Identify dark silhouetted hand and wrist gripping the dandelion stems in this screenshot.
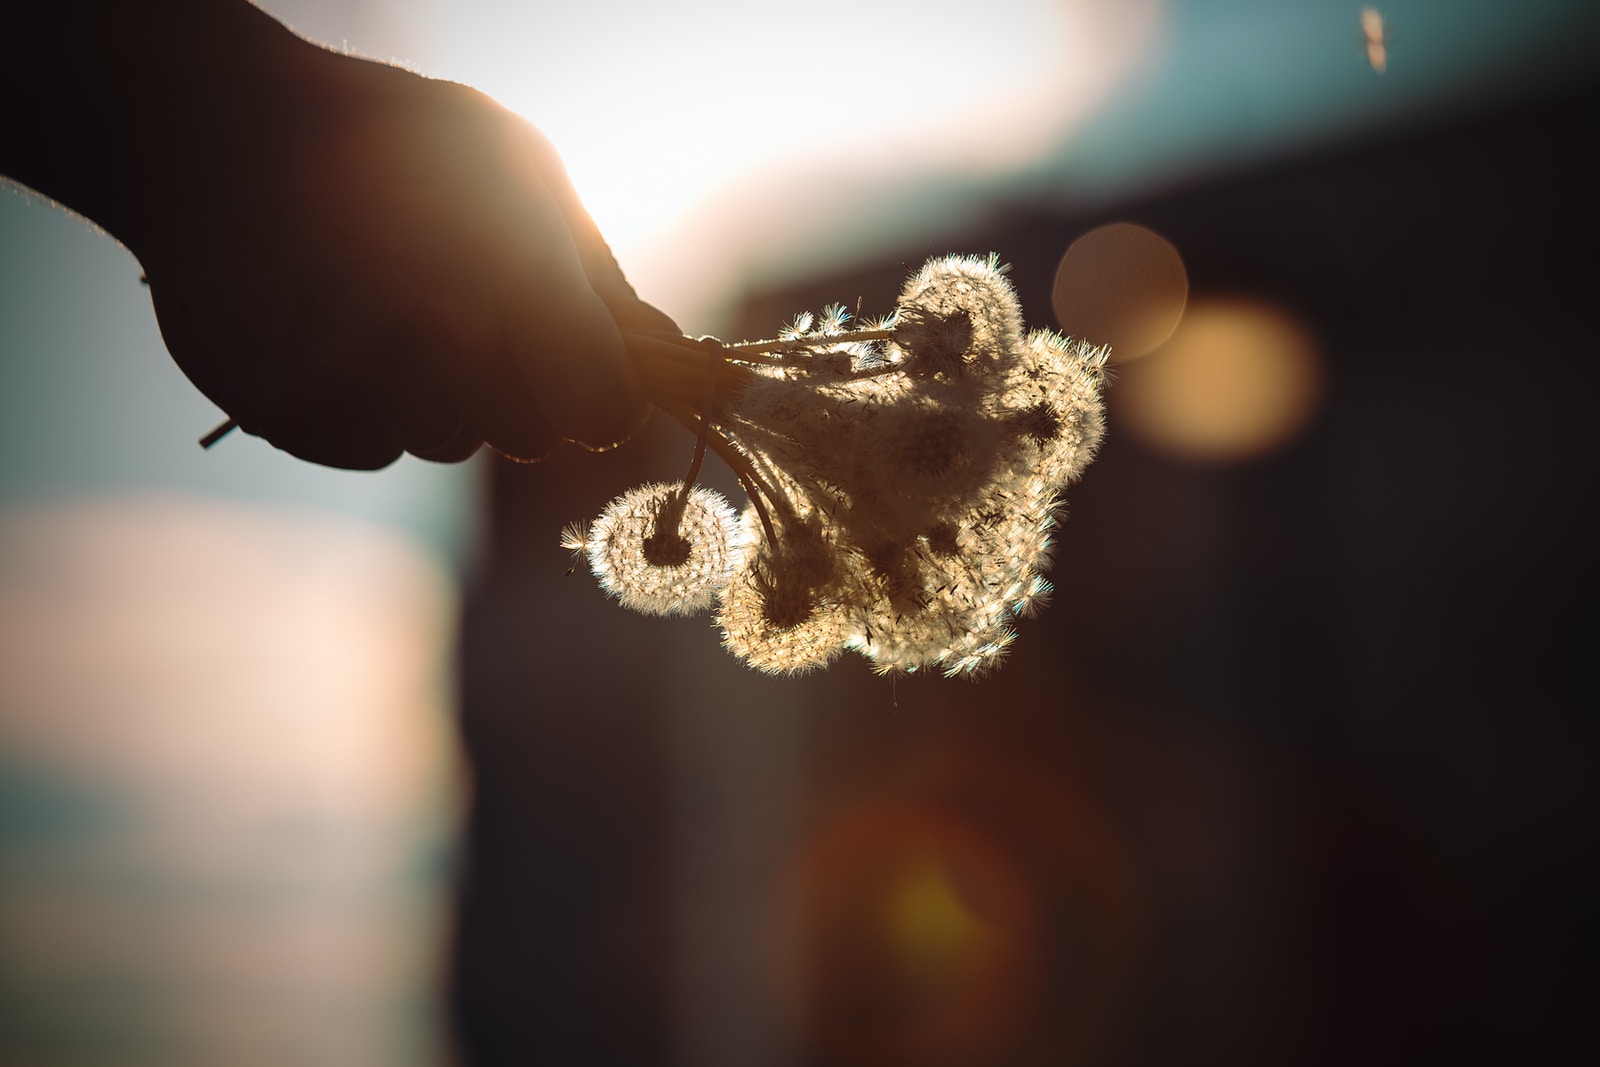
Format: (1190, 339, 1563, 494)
(0, 0, 675, 469)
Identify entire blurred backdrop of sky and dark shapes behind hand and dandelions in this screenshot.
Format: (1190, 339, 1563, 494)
(0, 0, 1600, 1067)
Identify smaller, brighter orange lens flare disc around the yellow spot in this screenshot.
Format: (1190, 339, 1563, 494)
(773, 803, 1040, 1064)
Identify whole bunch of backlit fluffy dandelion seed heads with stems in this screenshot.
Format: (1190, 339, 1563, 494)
(562, 256, 1109, 675)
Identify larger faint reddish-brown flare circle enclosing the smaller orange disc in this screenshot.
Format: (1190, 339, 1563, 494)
(765, 748, 1146, 1067)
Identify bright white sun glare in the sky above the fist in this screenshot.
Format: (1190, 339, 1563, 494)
(427, 0, 1157, 321)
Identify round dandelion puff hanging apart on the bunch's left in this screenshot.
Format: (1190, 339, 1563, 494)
(584, 485, 742, 614)
